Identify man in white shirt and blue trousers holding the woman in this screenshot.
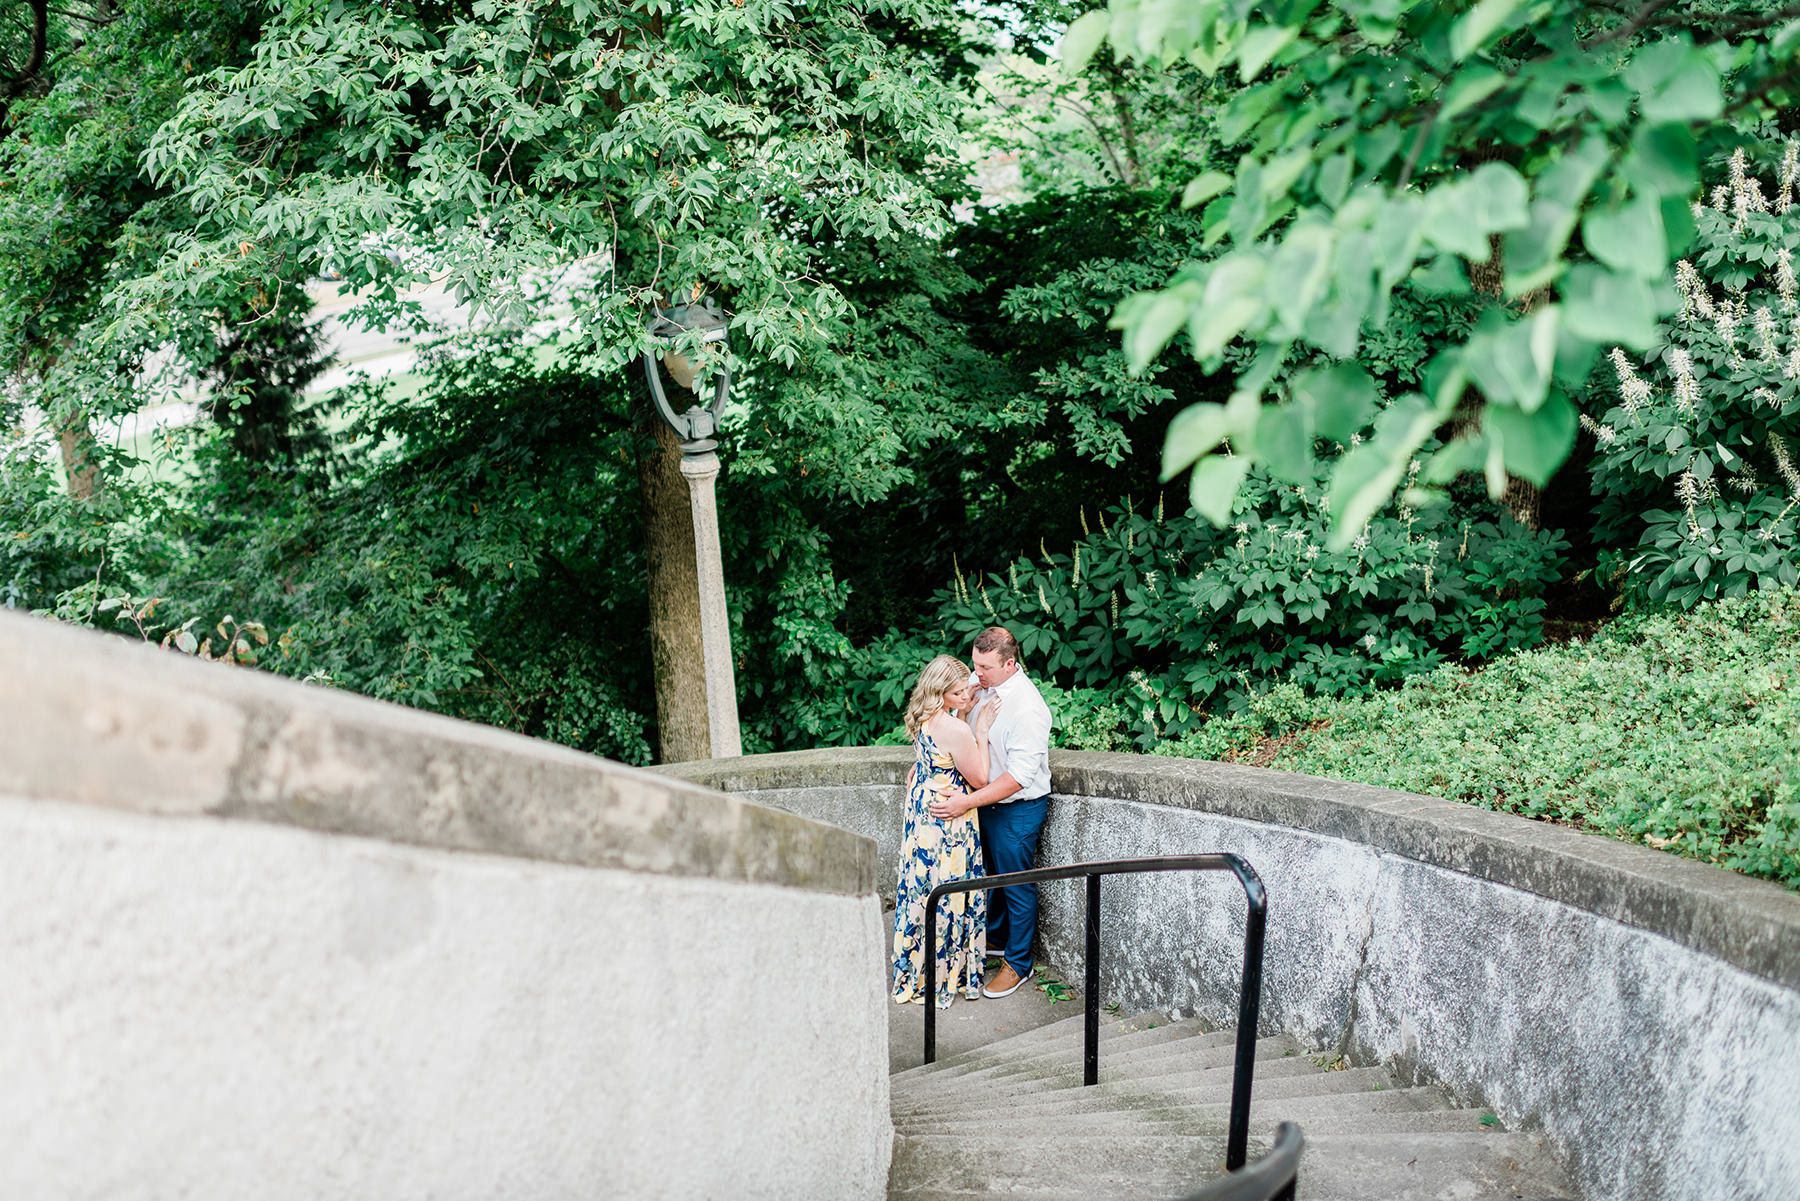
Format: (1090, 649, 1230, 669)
(931, 625, 1051, 998)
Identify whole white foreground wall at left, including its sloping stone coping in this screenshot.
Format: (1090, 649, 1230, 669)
(0, 612, 893, 1201)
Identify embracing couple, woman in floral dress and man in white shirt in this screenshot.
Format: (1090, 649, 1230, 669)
(893, 625, 1051, 1008)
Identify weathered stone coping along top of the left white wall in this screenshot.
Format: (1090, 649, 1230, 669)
(0, 610, 877, 895)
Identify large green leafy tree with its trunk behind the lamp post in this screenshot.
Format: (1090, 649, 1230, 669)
(95, 0, 954, 758)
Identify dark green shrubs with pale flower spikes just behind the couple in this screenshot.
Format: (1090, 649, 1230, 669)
(892, 466, 1566, 747)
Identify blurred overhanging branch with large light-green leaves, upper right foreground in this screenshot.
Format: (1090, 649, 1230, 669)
(1066, 0, 1800, 546)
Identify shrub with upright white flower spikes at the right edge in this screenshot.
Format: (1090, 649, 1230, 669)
(1584, 144, 1800, 607)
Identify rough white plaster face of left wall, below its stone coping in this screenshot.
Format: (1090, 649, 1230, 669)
(0, 798, 891, 1201)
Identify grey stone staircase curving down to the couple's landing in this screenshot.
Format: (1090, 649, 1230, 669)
(887, 1014, 1573, 1201)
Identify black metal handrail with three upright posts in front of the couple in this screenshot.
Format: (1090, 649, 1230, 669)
(925, 853, 1269, 1172)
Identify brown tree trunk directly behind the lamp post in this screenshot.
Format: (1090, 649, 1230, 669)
(634, 415, 713, 763)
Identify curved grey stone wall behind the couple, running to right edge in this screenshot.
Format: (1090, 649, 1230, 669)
(666, 749, 1800, 1201)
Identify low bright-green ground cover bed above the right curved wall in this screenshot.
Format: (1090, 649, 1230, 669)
(1157, 589, 1800, 889)
